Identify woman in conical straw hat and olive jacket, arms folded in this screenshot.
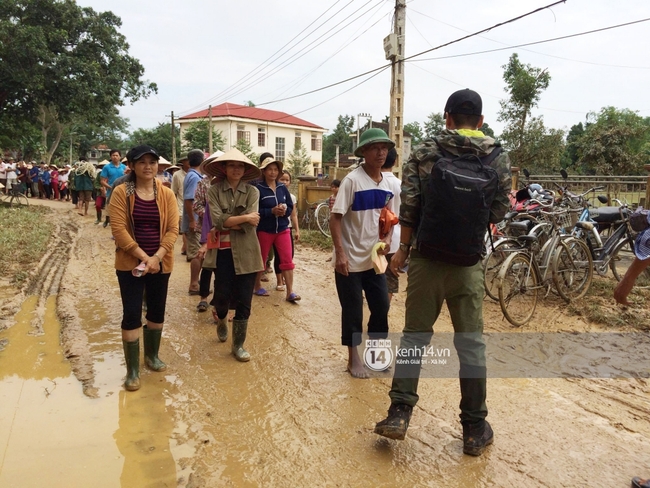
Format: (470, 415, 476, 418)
(203, 148, 264, 361)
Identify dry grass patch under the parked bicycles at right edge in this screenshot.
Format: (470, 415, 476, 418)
(567, 276, 650, 331)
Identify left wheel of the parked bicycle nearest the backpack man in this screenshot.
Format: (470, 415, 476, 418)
(499, 252, 540, 327)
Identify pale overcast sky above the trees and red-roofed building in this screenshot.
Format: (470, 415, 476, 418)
(77, 0, 650, 135)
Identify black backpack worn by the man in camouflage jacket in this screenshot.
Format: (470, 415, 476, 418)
(417, 141, 502, 266)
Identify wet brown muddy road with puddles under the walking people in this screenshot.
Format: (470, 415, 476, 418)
(0, 199, 650, 488)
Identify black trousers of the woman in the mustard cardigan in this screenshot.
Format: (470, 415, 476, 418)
(116, 271, 171, 330)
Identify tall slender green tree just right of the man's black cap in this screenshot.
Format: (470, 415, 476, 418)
(498, 53, 564, 173)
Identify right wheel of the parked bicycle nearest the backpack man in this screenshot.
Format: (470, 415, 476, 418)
(551, 237, 594, 302)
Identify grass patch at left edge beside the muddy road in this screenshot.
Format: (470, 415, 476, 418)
(0, 205, 54, 285)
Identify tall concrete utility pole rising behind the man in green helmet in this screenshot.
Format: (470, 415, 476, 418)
(384, 0, 406, 177)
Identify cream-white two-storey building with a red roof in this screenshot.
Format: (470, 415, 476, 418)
(178, 103, 327, 176)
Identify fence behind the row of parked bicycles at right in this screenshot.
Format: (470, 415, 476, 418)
(512, 164, 650, 207)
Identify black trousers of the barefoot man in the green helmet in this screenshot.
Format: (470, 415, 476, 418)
(334, 269, 390, 347)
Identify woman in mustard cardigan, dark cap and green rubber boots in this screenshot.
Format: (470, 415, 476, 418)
(109, 145, 178, 391)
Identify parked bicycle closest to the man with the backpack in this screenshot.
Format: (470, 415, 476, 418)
(498, 205, 593, 326)
